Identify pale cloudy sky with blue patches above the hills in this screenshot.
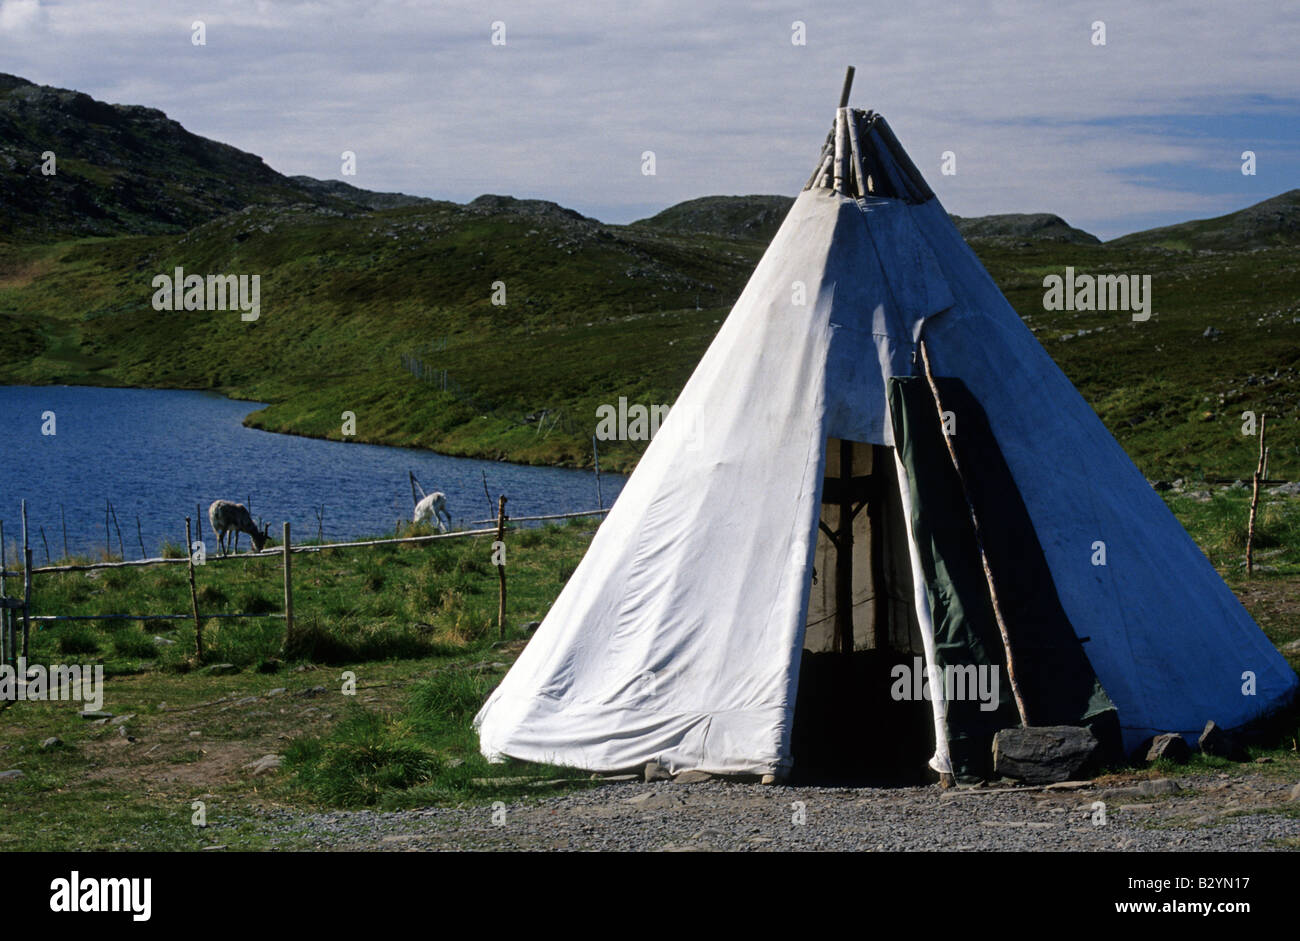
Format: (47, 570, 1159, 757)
(0, 0, 1300, 239)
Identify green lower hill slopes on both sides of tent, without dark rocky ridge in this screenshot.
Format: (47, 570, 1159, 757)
(0, 204, 1300, 478)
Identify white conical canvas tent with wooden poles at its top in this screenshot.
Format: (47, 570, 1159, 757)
(475, 102, 1296, 777)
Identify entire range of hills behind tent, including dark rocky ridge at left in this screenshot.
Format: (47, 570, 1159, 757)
(0, 75, 1300, 477)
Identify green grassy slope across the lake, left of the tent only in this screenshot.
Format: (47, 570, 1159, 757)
(0, 198, 762, 468)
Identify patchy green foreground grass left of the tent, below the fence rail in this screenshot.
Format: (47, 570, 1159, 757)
(0, 521, 590, 850)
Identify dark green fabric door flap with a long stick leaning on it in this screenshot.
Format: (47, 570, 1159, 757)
(889, 377, 1119, 776)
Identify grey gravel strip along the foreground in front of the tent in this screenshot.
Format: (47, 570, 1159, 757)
(245, 773, 1300, 851)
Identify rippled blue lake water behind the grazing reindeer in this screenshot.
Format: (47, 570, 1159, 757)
(0, 386, 624, 565)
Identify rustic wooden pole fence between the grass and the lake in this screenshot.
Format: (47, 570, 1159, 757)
(0, 496, 608, 664)
